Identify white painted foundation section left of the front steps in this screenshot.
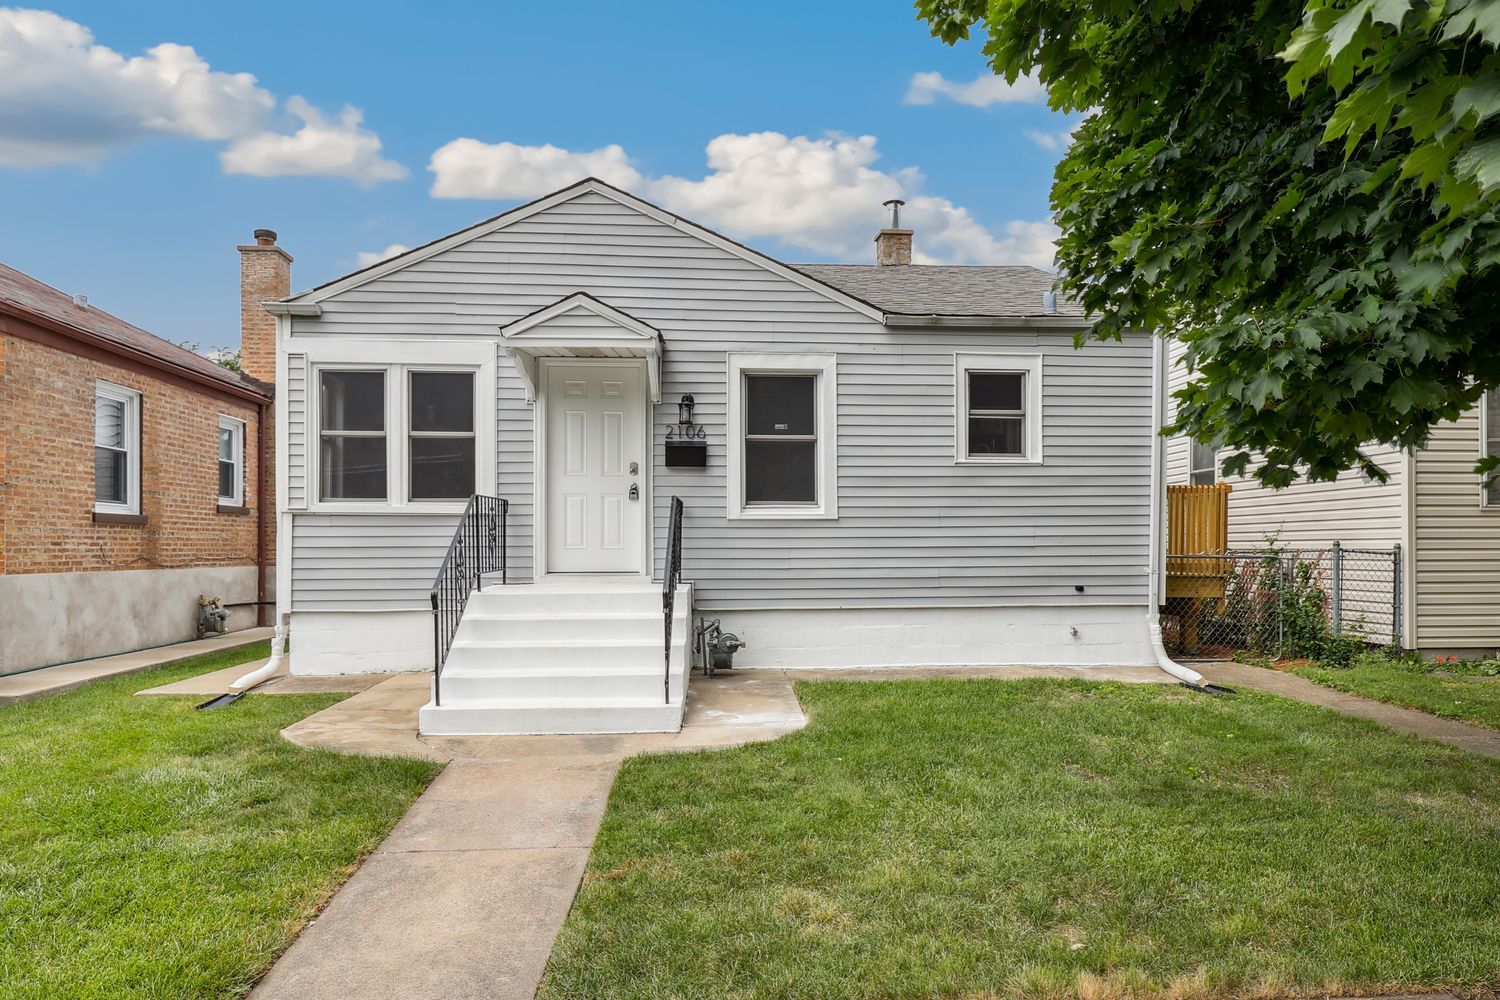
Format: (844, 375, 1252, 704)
(291, 610, 432, 676)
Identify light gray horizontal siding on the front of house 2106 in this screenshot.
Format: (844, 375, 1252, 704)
(288, 188, 1152, 609)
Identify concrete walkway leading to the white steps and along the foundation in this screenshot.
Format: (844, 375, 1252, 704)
(251, 667, 1172, 1000)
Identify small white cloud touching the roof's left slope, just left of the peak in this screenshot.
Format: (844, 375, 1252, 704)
(428, 139, 641, 198)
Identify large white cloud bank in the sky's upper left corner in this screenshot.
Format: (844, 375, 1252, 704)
(0, 7, 407, 184)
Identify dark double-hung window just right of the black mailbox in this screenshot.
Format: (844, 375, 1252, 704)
(744, 375, 818, 504)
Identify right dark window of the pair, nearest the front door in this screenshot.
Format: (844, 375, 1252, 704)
(410, 372, 474, 501)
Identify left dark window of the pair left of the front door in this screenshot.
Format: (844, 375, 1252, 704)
(318, 372, 386, 499)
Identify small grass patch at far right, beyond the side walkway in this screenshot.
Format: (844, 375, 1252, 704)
(1293, 654, 1500, 729)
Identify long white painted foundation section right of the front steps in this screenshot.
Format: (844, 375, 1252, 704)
(695, 606, 1157, 667)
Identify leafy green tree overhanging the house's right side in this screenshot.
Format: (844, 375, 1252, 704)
(917, 0, 1500, 486)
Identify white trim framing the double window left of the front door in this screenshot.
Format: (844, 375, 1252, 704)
(302, 337, 497, 514)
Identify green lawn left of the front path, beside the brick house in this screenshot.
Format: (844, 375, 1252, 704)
(0, 643, 440, 1000)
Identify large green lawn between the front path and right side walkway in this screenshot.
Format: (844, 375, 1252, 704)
(540, 681, 1500, 1000)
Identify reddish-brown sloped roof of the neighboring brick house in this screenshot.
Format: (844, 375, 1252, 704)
(0, 264, 270, 399)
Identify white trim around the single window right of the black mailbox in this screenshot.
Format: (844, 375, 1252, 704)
(725, 354, 839, 520)
